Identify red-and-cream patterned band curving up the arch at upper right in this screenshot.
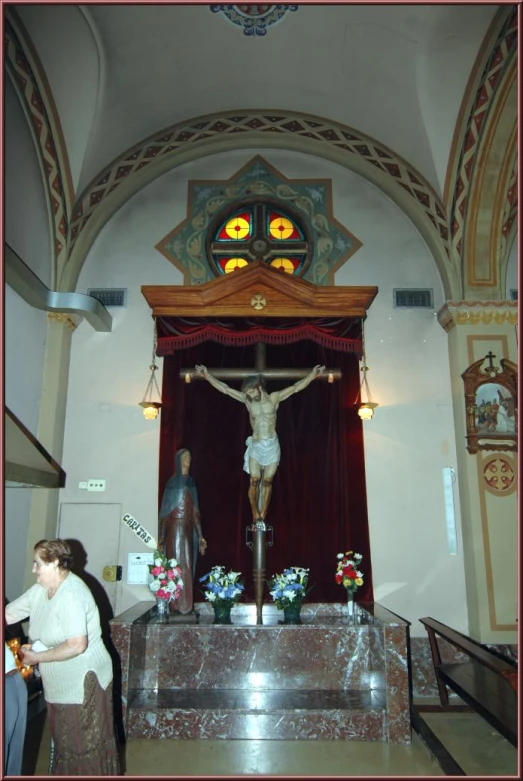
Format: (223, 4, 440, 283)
(449, 4, 518, 266)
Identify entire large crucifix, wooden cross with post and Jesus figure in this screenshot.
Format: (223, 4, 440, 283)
(180, 342, 341, 624)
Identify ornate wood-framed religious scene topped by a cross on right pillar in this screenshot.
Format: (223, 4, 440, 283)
(461, 352, 518, 453)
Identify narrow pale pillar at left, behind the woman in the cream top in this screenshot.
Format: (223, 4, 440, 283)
(25, 312, 83, 588)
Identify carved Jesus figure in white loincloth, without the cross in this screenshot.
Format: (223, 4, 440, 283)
(195, 365, 325, 523)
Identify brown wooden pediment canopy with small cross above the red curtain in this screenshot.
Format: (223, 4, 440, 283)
(142, 261, 378, 318)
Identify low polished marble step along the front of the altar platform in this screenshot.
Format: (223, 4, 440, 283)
(127, 689, 387, 741)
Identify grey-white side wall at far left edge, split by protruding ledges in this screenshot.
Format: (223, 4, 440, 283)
(4, 77, 51, 599)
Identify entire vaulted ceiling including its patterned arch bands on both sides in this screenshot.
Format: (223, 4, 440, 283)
(5, 2, 517, 298)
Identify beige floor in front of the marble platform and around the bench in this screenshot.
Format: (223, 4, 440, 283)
(24, 712, 518, 777)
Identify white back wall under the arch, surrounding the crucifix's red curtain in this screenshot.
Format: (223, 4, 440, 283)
(61, 150, 468, 635)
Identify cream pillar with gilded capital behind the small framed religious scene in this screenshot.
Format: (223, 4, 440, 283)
(436, 301, 518, 643)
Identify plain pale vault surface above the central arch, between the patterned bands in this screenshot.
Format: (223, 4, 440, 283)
(16, 3, 498, 194)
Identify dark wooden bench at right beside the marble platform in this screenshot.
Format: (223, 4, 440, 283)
(420, 618, 518, 747)
